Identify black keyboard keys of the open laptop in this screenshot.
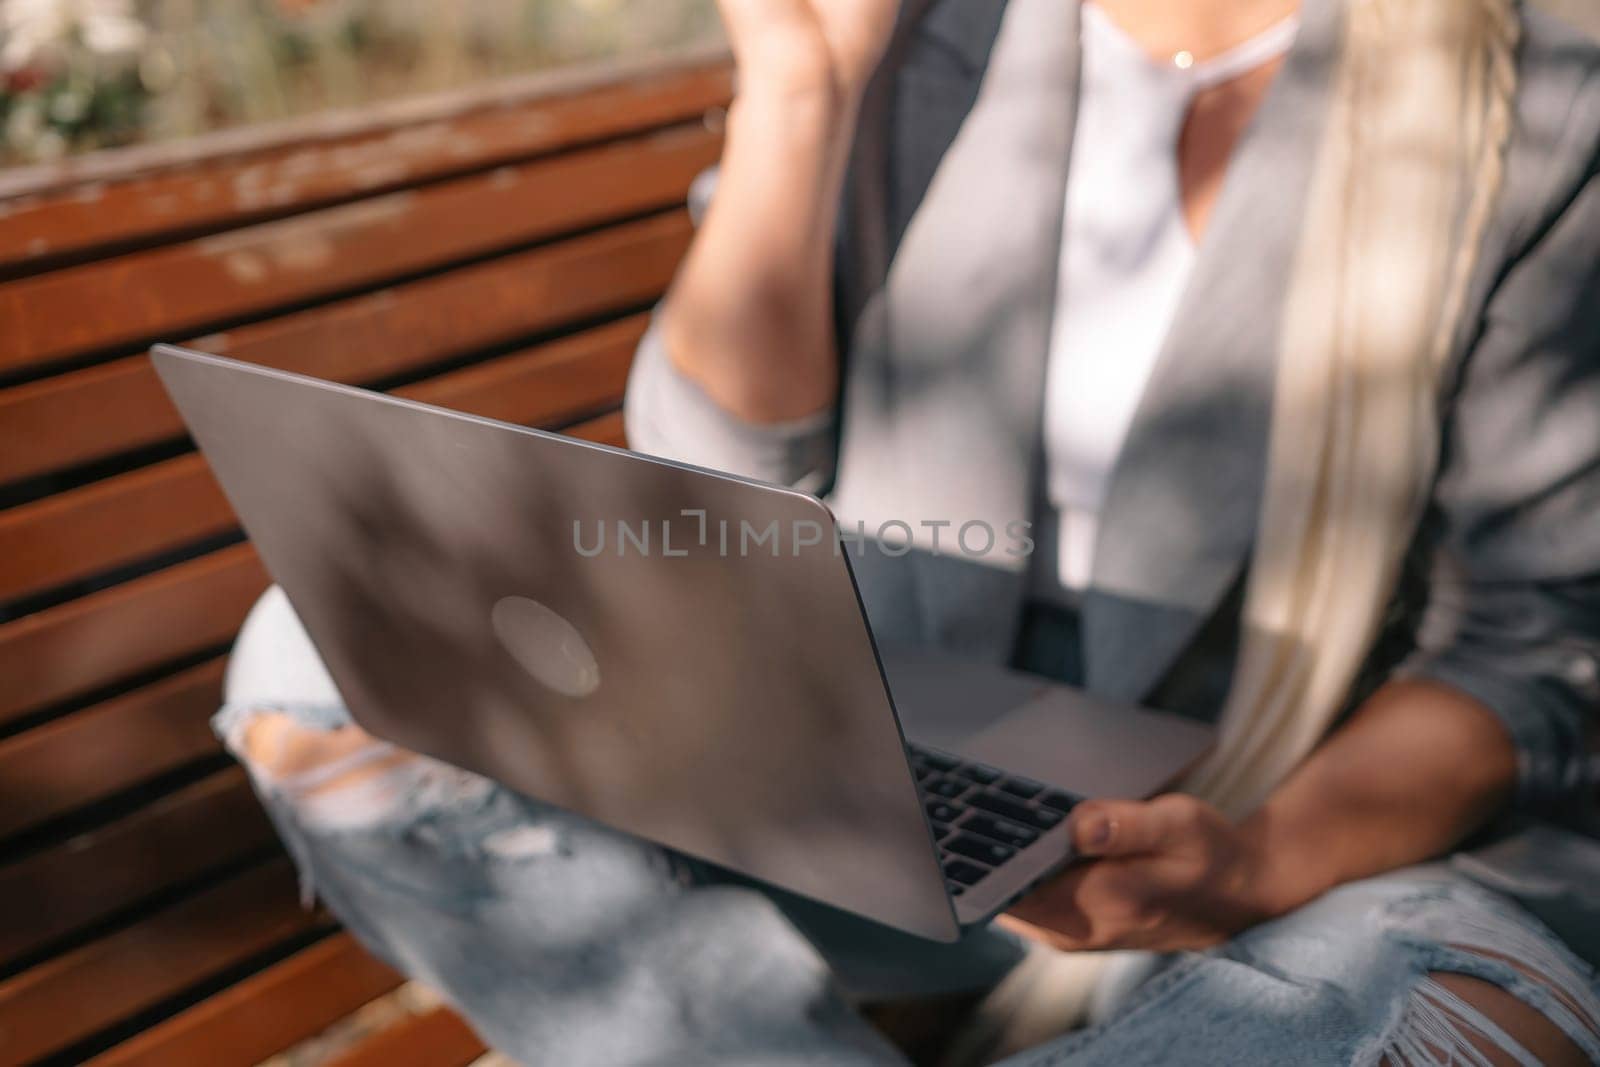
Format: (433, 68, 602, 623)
(906, 744, 1082, 896)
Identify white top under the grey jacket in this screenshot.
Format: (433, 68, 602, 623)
(1034, 3, 1299, 600)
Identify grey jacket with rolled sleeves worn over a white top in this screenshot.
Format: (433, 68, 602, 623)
(626, 0, 1600, 806)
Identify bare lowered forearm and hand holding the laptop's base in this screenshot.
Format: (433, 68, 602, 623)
(1002, 680, 1517, 950)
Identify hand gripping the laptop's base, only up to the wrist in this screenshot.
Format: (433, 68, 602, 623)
(1000, 793, 1299, 952)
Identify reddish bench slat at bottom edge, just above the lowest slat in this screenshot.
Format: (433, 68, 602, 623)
(88, 933, 402, 1067)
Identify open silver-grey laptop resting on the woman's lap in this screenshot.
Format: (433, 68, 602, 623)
(152, 346, 1213, 941)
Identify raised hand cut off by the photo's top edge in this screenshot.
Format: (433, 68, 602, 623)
(718, 0, 901, 102)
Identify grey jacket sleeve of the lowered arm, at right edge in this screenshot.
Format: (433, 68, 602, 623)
(1402, 154, 1600, 809)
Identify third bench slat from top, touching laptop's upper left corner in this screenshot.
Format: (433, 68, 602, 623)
(0, 211, 691, 483)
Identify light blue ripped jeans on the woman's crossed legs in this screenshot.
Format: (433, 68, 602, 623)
(216, 590, 1600, 1067)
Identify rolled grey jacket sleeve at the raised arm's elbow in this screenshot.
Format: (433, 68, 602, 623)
(622, 170, 835, 493)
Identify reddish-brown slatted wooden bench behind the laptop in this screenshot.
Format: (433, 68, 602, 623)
(0, 54, 731, 1067)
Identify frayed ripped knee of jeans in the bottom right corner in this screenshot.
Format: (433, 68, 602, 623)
(1379, 894, 1600, 1067)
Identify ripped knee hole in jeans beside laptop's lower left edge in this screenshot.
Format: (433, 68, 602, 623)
(224, 709, 493, 830)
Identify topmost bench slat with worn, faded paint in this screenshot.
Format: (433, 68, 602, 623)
(0, 58, 731, 269)
